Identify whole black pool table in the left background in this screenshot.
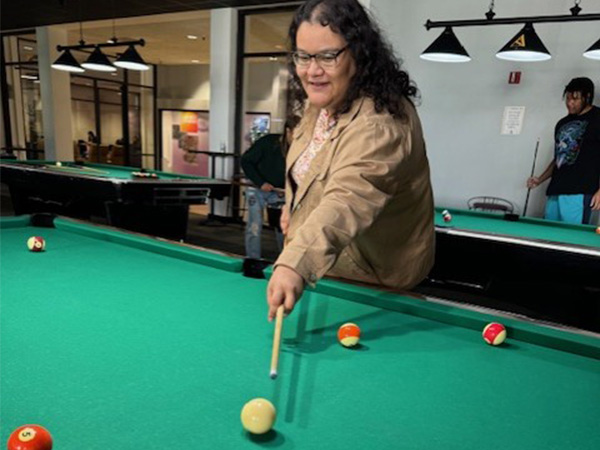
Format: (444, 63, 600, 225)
(0, 160, 231, 240)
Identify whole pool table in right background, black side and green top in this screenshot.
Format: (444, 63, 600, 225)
(430, 208, 600, 332)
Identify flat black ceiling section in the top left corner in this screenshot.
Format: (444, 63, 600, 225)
(0, 0, 296, 32)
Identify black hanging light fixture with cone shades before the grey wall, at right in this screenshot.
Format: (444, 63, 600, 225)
(421, 0, 600, 62)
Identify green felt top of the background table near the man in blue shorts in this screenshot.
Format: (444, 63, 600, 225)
(435, 208, 600, 248)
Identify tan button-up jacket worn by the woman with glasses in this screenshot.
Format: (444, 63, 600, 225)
(275, 98, 434, 289)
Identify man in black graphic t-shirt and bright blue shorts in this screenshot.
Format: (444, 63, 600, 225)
(527, 78, 600, 224)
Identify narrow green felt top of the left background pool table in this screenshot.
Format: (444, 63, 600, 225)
(2, 160, 209, 180)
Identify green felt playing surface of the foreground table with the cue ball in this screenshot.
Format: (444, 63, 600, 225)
(0, 219, 600, 450)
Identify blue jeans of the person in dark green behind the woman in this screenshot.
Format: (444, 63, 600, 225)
(246, 188, 285, 259)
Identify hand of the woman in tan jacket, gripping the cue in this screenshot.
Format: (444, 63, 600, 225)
(267, 266, 304, 322)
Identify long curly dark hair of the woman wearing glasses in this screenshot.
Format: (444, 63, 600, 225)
(288, 0, 418, 119)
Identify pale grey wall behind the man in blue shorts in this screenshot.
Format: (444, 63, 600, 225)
(370, 0, 600, 221)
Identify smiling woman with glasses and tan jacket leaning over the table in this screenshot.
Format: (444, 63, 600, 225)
(267, 0, 434, 320)
